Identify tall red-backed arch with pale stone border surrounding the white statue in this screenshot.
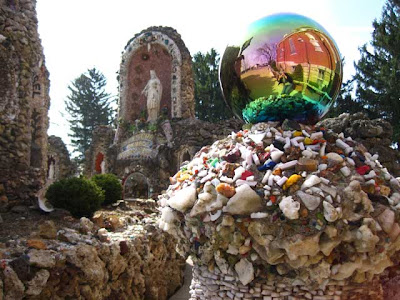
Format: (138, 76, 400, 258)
(114, 26, 195, 143)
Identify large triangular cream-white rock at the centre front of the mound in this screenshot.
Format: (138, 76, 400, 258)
(223, 184, 263, 215)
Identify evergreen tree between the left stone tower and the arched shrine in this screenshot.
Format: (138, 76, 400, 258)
(65, 68, 115, 162)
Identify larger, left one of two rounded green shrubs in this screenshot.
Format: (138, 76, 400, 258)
(46, 177, 104, 218)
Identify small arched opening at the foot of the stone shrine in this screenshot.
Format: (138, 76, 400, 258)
(123, 172, 150, 199)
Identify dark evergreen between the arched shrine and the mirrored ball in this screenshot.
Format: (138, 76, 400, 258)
(193, 48, 233, 122)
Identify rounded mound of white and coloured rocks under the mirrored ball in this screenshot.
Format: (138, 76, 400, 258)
(159, 121, 400, 299)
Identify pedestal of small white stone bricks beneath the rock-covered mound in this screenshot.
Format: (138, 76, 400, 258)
(190, 265, 383, 300)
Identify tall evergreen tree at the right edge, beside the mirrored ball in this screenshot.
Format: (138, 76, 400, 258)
(354, 0, 400, 142)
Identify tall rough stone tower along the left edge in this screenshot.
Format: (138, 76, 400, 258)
(0, 0, 50, 207)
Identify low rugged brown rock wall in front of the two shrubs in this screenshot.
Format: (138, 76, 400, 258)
(0, 201, 185, 300)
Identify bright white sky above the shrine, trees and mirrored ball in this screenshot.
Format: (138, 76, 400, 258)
(36, 0, 385, 152)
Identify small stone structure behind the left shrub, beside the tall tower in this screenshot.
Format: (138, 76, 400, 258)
(46, 135, 76, 181)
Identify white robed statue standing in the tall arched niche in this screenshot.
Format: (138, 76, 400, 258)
(142, 70, 162, 123)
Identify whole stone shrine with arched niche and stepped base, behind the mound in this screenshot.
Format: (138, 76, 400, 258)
(85, 27, 241, 198)
